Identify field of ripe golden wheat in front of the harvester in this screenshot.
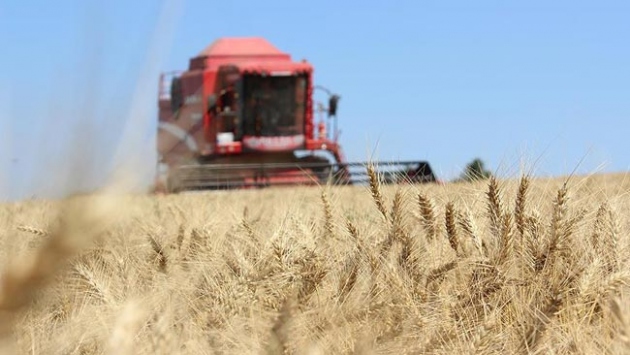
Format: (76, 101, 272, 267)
(0, 173, 630, 355)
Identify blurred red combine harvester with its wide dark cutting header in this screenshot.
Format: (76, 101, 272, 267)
(156, 37, 436, 192)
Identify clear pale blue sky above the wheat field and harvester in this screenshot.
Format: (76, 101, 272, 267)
(0, 0, 630, 198)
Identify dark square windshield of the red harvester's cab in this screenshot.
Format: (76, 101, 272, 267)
(243, 75, 307, 136)
